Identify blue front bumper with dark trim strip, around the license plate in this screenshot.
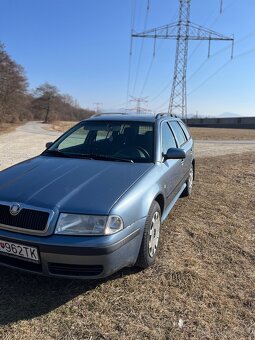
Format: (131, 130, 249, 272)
(0, 218, 145, 279)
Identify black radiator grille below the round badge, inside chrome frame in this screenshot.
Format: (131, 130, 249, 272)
(0, 204, 50, 231)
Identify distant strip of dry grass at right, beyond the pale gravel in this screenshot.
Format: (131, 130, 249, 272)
(190, 128, 255, 140)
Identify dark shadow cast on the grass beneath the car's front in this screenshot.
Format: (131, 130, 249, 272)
(0, 267, 139, 326)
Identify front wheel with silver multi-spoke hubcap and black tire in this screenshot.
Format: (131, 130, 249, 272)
(136, 202, 161, 268)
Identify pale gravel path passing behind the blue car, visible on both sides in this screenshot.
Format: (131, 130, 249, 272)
(0, 122, 255, 170)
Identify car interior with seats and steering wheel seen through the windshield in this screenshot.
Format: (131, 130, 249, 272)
(55, 123, 154, 162)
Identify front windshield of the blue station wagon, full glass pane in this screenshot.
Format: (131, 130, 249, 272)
(43, 120, 154, 163)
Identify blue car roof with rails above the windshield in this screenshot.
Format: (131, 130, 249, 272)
(85, 113, 180, 123)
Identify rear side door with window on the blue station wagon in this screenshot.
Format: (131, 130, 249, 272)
(170, 121, 193, 182)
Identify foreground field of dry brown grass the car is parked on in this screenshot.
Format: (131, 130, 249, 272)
(0, 153, 255, 340)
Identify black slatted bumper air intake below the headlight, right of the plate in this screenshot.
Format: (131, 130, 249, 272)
(48, 263, 104, 276)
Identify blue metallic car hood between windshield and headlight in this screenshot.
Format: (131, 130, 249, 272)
(0, 156, 153, 214)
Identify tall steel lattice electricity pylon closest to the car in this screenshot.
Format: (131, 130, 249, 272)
(132, 0, 234, 119)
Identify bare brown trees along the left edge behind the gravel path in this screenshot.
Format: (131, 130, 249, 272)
(0, 43, 95, 123)
